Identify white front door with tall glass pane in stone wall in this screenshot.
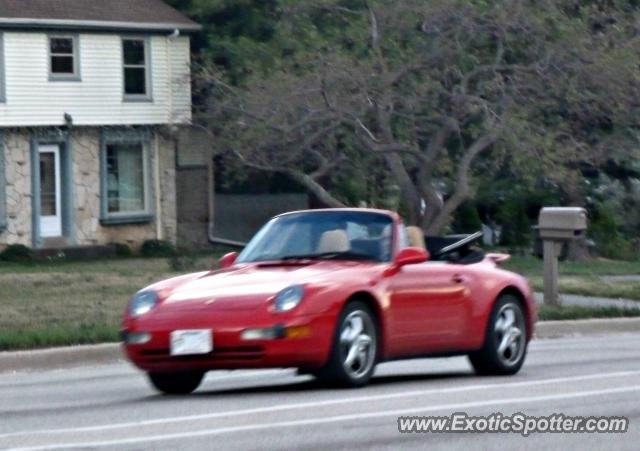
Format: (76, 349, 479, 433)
(39, 145, 62, 238)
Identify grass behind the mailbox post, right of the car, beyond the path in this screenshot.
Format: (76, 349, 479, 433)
(504, 256, 640, 300)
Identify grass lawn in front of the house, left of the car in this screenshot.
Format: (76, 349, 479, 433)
(0, 256, 215, 350)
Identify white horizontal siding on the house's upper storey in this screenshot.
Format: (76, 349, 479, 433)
(0, 31, 191, 127)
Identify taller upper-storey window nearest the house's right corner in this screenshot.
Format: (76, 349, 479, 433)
(122, 39, 151, 100)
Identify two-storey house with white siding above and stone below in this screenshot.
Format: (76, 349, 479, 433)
(0, 0, 200, 249)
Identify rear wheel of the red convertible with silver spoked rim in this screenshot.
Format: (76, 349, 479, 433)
(469, 294, 528, 375)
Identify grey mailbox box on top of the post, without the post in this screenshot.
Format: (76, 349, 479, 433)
(538, 207, 587, 241)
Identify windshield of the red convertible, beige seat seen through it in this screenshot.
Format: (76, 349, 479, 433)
(237, 211, 393, 263)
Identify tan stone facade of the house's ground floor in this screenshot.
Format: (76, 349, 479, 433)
(0, 127, 177, 248)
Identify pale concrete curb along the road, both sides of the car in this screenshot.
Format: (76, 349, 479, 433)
(0, 318, 640, 373)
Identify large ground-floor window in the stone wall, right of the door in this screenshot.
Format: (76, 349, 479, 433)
(105, 143, 147, 216)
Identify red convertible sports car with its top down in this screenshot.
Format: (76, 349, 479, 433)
(123, 209, 537, 394)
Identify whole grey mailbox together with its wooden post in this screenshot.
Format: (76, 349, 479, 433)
(538, 207, 587, 305)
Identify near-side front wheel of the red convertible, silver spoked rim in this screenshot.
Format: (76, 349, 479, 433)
(313, 301, 379, 388)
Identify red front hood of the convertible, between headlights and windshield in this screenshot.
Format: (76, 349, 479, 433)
(162, 261, 369, 310)
